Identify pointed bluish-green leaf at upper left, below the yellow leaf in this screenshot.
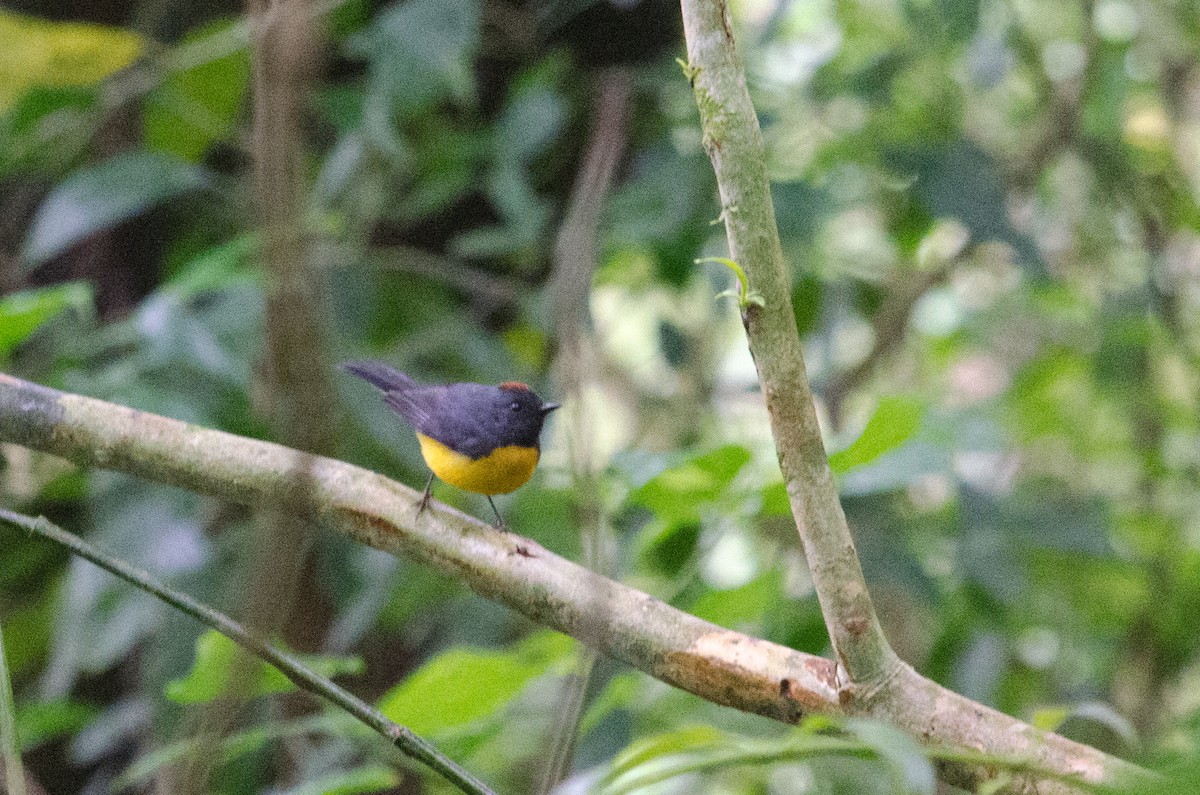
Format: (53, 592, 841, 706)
(22, 151, 209, 268)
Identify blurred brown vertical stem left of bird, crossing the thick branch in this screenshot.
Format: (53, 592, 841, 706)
(175, 0, 335, 791)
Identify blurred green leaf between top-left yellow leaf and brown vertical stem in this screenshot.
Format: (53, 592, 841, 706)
(142, 20, 250, 162)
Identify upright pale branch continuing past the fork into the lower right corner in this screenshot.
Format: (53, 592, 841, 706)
(682, 0, 1136, 794)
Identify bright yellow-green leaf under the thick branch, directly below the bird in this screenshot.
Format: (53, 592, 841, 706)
(378, 633, 572, 734)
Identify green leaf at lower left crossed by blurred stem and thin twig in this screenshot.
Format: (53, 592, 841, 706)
(166, 629, 364, 704)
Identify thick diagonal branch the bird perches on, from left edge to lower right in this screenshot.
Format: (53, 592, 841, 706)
(0, 373, 1138, 795)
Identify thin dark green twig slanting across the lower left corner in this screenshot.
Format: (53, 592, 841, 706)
(0, 508, 492, 795)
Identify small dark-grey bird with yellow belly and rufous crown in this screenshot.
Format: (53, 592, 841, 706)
(340, 360, 559, 530)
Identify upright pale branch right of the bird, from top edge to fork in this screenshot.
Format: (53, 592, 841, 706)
(682, 0, 898, 688)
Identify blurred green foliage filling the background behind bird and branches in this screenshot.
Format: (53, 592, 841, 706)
(0, 0, 1200, 795)
